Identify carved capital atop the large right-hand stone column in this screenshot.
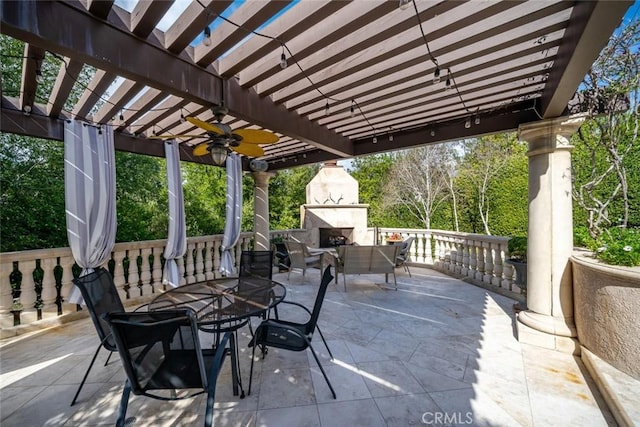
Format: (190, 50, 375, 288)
(518, 114, 587, 157)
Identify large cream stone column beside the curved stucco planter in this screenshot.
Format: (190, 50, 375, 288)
(517, 116, 584, 353)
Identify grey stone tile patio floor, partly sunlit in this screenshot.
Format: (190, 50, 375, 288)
(0, 268, 615, 427)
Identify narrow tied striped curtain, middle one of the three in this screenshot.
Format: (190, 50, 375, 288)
(158, 141, 187, 288)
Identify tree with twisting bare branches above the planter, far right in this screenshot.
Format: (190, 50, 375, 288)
(572, 21, 640, 237)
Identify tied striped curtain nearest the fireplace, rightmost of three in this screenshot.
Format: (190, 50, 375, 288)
(220, 153, 242, 276)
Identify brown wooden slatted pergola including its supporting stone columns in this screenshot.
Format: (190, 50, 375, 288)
(0, 0, 632, 372)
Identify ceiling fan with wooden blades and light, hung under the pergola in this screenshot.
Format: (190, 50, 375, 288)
(152, 106, 279, 166)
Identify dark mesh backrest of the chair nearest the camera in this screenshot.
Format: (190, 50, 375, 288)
(106, 310, 207, 397)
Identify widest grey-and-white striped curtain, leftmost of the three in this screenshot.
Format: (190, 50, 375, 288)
(64, 120, 116, 304)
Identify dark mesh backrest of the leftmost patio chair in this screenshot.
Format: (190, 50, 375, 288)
(73, 268, 124, 351)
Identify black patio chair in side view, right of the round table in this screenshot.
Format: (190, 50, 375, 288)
(247, 266, 336, 399)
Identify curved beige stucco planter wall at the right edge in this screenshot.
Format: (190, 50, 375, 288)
(571, 256, 640, 380)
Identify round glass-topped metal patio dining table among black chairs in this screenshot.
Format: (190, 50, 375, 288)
(149, 277, 286, 398)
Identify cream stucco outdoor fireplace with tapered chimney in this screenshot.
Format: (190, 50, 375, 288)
(300, 162, 371, 247)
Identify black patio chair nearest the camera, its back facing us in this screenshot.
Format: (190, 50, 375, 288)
(105, 309, 230, 427)
